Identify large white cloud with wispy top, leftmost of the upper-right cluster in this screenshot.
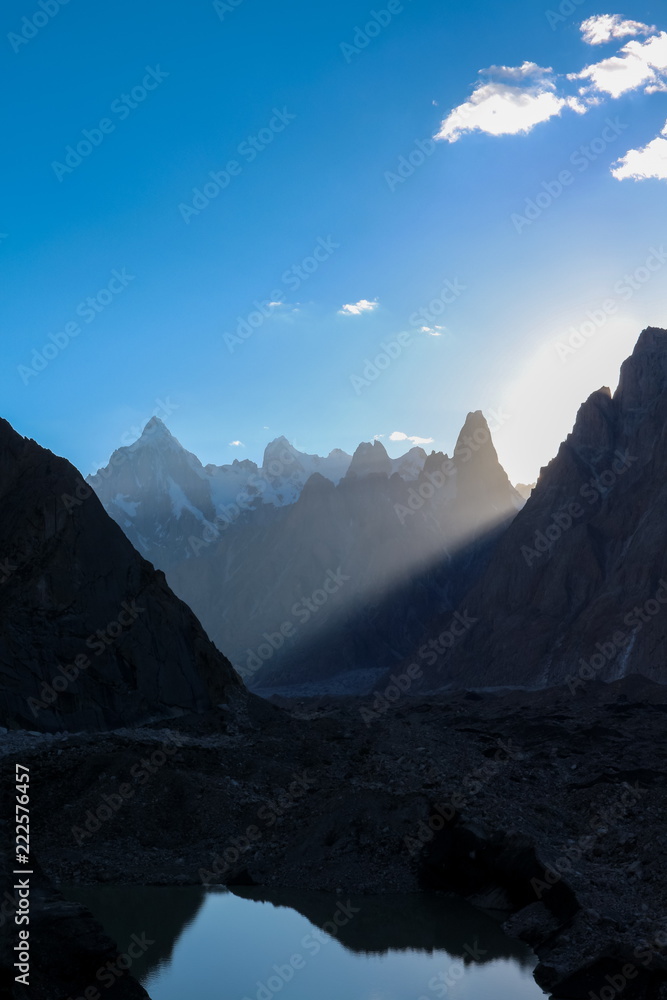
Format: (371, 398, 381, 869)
(435, 62, 586, 142)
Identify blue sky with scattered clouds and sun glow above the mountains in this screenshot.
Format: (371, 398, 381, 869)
(0, 0, 667, 481)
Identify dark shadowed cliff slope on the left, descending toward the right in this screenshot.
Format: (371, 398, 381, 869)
(0, 420, 243, 731)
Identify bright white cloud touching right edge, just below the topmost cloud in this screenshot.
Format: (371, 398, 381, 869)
(569, 31, 667, 97)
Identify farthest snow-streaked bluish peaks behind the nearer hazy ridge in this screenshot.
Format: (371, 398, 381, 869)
(87, 417, 434, 570)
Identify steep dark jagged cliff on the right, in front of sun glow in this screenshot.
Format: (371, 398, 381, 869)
(420, 328, 667, 690)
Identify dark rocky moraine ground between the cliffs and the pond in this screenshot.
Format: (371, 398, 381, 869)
(2, 678, 667, 1000)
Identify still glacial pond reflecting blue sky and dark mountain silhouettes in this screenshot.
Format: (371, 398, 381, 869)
(64, 886, 545, 1000)
